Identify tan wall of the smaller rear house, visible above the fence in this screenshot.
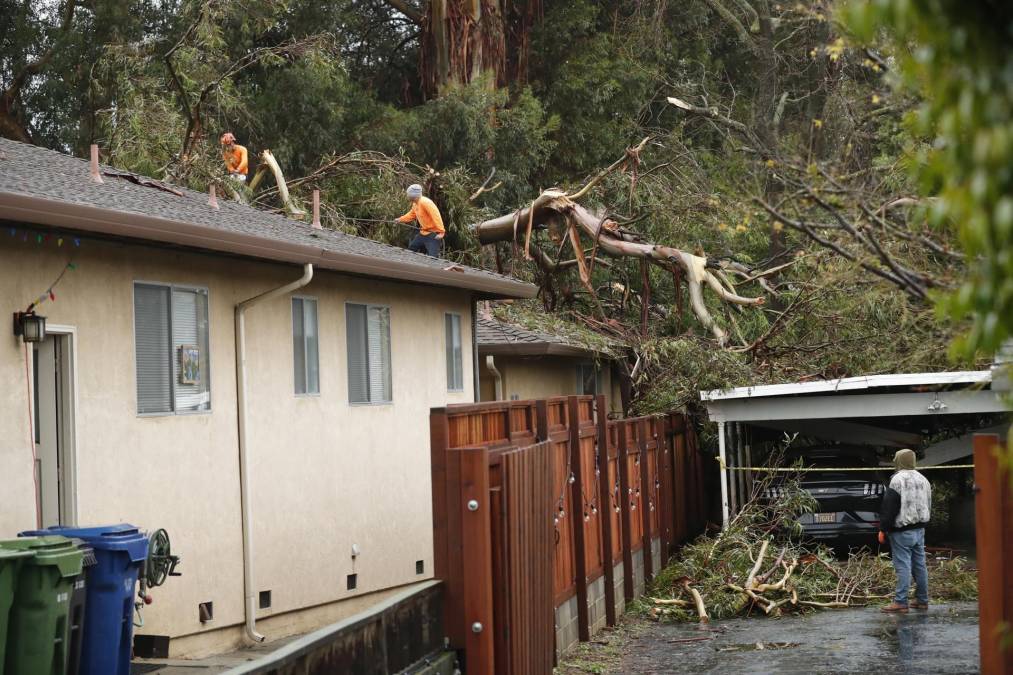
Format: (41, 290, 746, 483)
(478, 355, 622, 413)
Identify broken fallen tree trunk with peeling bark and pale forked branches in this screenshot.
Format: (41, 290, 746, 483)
(474, 138, 774, 346)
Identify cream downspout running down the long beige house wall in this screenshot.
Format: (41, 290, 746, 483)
(236, 265, 313, 643)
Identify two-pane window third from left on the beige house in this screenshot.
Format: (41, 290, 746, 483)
(344, 303, 391, 403)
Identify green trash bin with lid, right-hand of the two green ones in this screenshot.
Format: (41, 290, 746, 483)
(0, 536, 83, 675)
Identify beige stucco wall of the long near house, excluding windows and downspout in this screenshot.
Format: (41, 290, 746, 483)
(0, 232, 472, 648)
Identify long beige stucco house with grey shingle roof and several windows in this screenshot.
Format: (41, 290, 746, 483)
(0, 140, 535, 657)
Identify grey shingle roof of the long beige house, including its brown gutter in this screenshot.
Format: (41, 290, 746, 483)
(0, 139, 535, 297)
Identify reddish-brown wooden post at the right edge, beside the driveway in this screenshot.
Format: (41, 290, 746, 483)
(975, 434, 1013, 675)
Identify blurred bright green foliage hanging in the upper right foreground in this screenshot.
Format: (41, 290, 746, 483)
(846, 0, 1013, 358)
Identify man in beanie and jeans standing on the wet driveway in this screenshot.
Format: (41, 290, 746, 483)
(879, 450, 932, 614)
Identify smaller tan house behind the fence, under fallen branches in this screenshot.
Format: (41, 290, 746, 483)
(476, 315, 623, 415)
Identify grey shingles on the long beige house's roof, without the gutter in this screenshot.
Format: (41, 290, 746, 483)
(0, 139, 535, 297)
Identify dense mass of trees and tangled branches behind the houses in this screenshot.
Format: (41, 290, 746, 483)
(0, 0, 996, 410)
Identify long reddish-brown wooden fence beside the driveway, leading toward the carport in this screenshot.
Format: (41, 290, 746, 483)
(431, 396, 713, 675)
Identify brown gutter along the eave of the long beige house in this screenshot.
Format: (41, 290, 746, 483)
(0, 193, 538, 298)
